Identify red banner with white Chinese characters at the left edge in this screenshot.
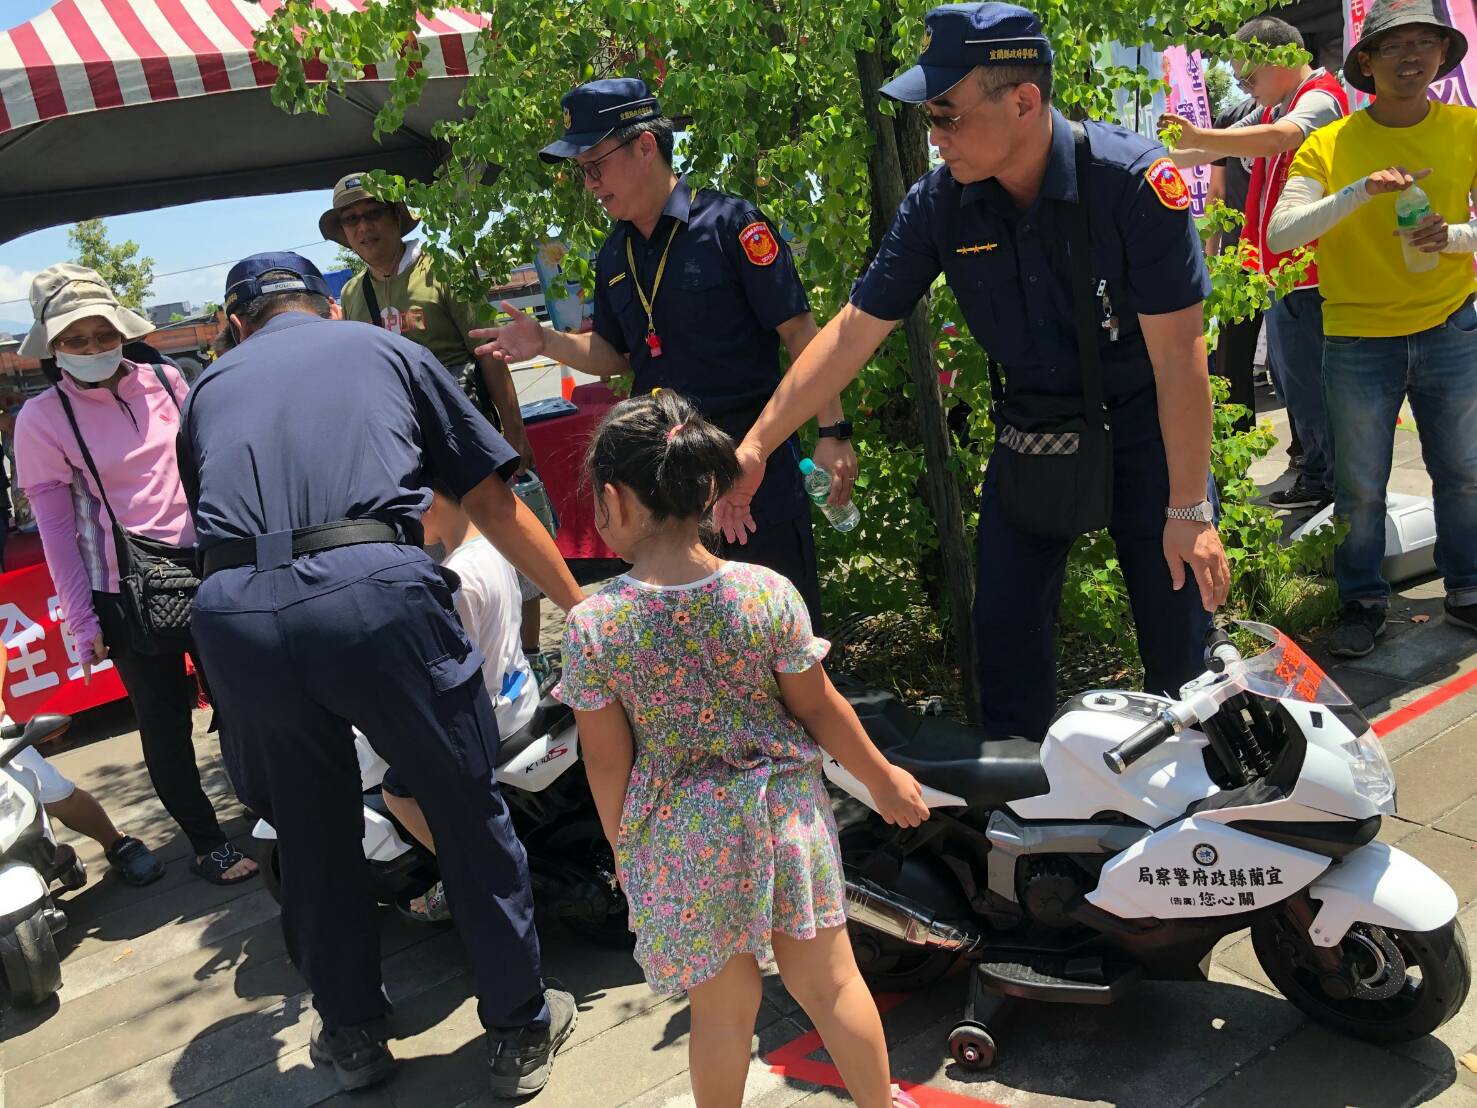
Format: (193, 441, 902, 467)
(0, 563, 124, 722)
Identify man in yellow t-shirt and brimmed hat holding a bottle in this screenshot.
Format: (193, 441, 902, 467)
(1267, 0, 1477, 657)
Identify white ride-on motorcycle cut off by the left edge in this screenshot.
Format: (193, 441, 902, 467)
(0, 715, 87, 1008)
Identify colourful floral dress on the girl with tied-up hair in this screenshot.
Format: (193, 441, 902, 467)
(554, 561, 845, 993)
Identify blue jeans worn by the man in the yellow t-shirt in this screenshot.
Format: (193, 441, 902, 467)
(1323, 301, 1477, 604)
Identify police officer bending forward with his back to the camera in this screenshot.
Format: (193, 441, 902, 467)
(180, 253, 580, 1098)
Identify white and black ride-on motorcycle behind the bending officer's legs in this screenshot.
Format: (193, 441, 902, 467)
(251, 696, 634, 947)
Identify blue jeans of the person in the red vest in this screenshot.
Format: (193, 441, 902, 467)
(1267, 288, 1334, 489)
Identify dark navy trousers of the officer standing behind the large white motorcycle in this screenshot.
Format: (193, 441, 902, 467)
(975, 413, 1214, 739)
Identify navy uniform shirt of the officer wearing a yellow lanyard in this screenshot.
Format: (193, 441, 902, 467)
(594, 177, 811, 521)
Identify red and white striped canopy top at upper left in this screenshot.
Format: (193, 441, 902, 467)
(0, 0, 487, 134)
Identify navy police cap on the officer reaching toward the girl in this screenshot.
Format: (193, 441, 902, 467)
(880, 3, 1052, 103)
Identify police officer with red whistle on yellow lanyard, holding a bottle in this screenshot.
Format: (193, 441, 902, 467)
(473, 77, 857, 623)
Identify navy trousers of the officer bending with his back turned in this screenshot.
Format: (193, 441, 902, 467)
(193, 535, 548, 1028)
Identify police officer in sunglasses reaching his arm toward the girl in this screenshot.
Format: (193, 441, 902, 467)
(716, 3, 1229, 747)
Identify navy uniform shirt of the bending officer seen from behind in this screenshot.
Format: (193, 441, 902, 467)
(180, 312, 518, 548)
